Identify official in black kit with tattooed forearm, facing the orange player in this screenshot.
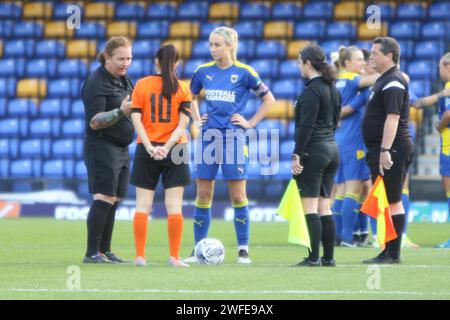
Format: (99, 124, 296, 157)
(82, 37, 134, 263)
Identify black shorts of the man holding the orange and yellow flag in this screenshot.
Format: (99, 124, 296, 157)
(366, 139, 415, 203)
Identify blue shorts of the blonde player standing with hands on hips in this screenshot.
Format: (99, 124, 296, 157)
(194, 130, 248, 180)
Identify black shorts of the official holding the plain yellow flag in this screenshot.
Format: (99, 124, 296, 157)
(294, 141, 339, 198)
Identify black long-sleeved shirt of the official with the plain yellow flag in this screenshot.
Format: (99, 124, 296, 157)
(294, 77, 341, 156)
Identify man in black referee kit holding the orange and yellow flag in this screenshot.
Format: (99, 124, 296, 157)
(362, 37, 414, 263)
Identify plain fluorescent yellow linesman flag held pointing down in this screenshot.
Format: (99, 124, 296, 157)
(277, 179, 311, 250)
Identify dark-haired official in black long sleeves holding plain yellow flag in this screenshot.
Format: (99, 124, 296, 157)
(292, 45, 341, 267)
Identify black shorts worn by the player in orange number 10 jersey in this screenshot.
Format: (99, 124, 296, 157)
(131, 143, 191, 190)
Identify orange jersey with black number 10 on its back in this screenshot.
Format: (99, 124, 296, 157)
(132, 75, 192, 143)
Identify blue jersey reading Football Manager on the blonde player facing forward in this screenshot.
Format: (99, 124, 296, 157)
(191, 61, 262, 130)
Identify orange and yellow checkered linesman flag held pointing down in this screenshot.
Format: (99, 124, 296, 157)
(361, 176, 397, 249)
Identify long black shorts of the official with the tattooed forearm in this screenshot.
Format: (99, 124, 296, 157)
(84, 136, 130, 198)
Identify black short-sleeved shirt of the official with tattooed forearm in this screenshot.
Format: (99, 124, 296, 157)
(81, 66, 134, 147)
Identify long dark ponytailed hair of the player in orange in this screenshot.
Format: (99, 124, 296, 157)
(156, 44, 178, 100)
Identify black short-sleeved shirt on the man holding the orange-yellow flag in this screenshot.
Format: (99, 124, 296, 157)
(362, 66, 410, 148)
